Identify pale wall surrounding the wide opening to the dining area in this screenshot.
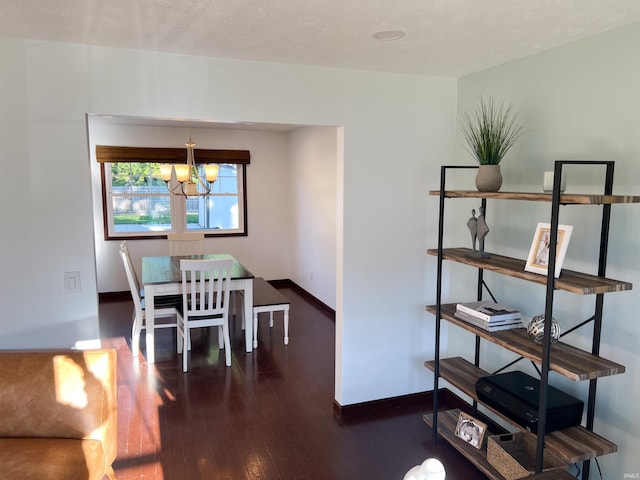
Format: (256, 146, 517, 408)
(0, 35, 457, 405)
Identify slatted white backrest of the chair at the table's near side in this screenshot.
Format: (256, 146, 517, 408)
(180, 258, 233, 317)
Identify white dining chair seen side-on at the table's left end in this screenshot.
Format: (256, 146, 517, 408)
(120, 241, 182, 357)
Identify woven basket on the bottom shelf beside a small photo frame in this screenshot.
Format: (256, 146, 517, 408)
(487, 432, 568, 480)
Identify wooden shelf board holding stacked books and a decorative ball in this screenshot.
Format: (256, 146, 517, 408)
(426, 303, 625, 381)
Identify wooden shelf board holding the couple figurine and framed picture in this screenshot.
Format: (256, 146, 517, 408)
(427, 247, 632, 295)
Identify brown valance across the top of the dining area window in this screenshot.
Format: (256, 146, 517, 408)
(96, 145, 251, 165)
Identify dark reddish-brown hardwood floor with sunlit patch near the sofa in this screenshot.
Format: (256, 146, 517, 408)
(100, 288, 484, 480)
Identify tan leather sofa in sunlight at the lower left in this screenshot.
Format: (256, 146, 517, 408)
(0, 349, 117, 480)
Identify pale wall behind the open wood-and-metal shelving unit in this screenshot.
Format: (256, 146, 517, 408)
(449, 23, 640, 479)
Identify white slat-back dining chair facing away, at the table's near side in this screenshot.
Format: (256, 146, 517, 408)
(178, 258, 233, 372)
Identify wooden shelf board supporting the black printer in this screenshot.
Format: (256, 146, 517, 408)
(424, 357, 618, 463)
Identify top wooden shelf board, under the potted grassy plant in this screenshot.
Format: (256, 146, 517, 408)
(429, 190, 640, 205)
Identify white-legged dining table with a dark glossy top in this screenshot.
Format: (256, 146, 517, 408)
(142, 253, 254, 363)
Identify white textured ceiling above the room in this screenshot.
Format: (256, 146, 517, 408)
(0, 0, 640, 76)
